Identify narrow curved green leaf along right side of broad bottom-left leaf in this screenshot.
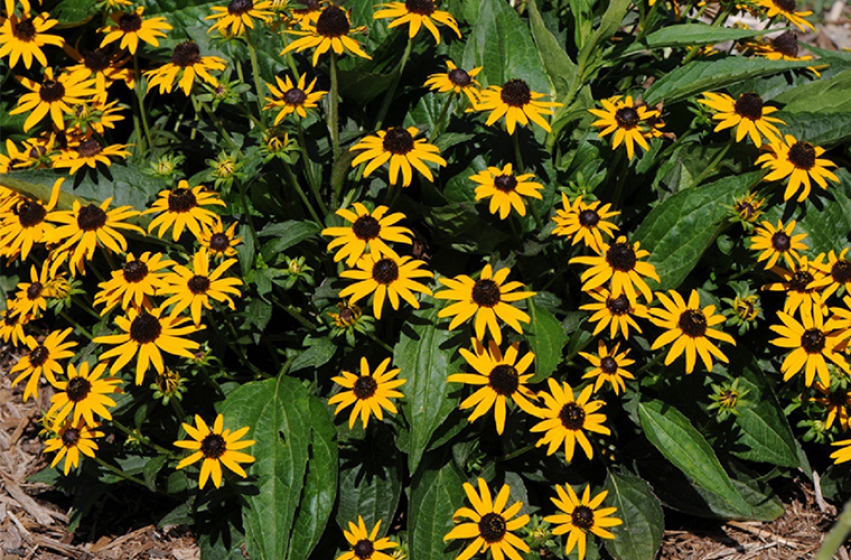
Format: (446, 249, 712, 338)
(288, 397, 338, 560)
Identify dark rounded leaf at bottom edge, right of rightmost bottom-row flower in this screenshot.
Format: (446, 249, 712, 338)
(603, 471, 665, 560)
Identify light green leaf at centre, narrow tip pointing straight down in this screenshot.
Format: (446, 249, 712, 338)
(393, 307, 461, 473)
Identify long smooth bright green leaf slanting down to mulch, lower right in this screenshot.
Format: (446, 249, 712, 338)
(638, 400, 750, 511)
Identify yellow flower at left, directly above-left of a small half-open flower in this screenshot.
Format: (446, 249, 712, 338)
(143, 179, 225, 241)
